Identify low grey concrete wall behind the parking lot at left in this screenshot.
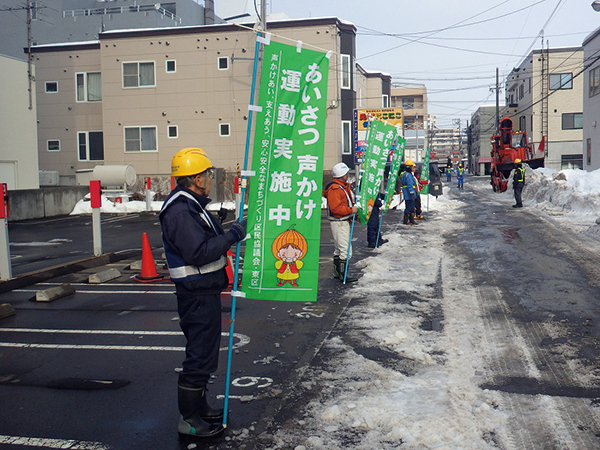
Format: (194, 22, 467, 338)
(8, 186, 90, 222)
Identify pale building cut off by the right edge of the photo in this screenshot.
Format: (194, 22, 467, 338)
(582, 28, 600, 171)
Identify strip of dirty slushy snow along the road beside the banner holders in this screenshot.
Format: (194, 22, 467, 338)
(266, 203, 507, 450)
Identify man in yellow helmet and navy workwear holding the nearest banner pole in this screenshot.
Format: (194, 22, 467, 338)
(159, 148, 246, 437)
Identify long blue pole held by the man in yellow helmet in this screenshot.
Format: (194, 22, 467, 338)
(223, 33, 260, 428)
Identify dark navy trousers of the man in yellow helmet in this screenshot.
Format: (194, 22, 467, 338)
(177, 293, 221, 387)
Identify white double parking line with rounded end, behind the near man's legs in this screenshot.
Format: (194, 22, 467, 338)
(0, 328, 250, 352)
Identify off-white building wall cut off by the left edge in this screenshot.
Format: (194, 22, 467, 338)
(0, 55, 39, 191)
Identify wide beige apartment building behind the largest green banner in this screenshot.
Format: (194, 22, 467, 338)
(34, 18, 389, 184)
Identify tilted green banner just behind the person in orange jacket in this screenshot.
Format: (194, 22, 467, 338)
(358, 119, 398, 225)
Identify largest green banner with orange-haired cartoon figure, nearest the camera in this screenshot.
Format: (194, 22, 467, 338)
(241, 41, 329, 302)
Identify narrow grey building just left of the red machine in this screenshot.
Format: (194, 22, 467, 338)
(468, 105, 496, 175)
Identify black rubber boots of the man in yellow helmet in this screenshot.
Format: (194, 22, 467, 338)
(177, 385, 224, 437)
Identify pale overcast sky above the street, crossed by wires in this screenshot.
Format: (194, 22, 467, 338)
(260, 0, 600, 128)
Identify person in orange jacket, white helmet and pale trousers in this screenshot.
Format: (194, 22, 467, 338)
(323, 163, 358, 283)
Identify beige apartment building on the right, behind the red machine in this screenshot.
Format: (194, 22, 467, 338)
(502, 47, 584, 170)
